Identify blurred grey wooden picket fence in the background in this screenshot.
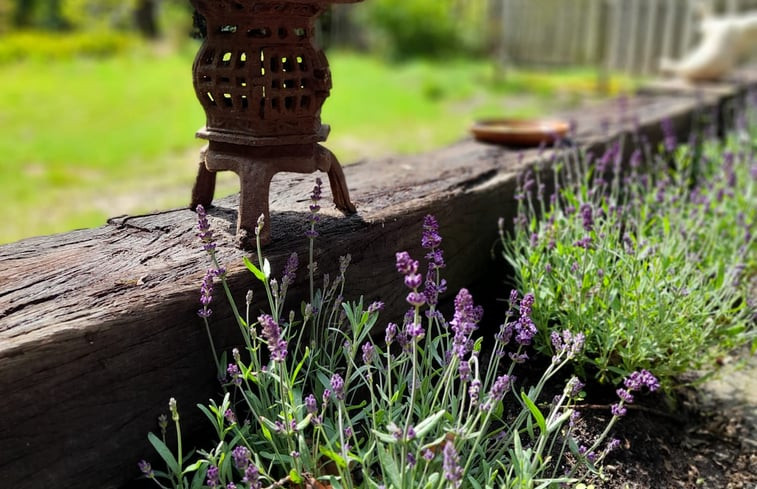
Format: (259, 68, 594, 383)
(493, 0, 757, 74)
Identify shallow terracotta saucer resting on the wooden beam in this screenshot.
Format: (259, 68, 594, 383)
(471, 119, 570, 146)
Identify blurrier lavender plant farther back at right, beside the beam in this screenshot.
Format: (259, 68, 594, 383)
(501, 104, 757, 388)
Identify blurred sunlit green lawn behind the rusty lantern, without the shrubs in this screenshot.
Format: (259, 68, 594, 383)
(0, 45, 628, 243)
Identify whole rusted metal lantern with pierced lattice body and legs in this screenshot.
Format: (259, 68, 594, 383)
(190, 0, 361, 246)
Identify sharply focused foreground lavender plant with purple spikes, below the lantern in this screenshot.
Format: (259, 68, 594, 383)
(140, 194, 636, 489)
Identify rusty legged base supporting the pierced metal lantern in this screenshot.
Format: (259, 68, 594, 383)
(190, 141, 357, 248)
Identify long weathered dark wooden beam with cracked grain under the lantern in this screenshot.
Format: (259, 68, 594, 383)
(0, 69, 757, 489)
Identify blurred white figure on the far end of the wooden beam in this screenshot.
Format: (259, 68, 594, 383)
(660, 7, 757, 81)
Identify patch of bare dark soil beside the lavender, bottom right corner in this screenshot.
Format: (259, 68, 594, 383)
(584, 351, 757, 489)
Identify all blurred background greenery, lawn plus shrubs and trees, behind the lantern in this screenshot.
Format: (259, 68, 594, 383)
(0, 0, 633, 243)
